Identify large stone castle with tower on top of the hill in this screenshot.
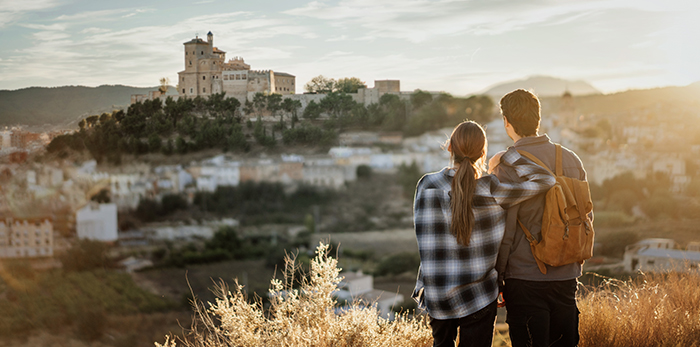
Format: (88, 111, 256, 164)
(178, 31, 296, 103)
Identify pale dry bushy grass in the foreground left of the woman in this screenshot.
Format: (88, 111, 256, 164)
(156, 244, 432, 347)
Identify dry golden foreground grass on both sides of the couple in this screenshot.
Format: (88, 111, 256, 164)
(156, 243, 700, 347)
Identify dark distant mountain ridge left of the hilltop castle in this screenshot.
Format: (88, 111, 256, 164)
(0, 85, 177, 126)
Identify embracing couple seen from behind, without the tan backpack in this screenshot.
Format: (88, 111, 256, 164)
(413, 89, 586, 347)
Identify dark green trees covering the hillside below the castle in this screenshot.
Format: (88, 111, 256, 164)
(47, 91, 494, 165)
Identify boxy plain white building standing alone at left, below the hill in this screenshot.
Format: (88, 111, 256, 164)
(75, 202, 118, 242)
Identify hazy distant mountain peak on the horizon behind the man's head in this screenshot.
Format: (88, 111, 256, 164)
(483, 76, 600, 100)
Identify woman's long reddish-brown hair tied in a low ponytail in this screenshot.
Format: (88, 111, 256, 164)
(447, 121, 486, 246)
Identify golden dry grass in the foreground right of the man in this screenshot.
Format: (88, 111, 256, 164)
(579, 272, 700, 347)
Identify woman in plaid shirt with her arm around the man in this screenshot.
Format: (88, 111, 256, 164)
(413, 121, 555, 347)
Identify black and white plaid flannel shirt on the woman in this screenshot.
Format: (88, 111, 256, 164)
(412, 148, 555, 319)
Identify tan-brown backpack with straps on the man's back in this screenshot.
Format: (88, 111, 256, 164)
(518, 144, 595, 274)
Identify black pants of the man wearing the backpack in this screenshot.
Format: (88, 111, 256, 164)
(503, 279, 579, 347)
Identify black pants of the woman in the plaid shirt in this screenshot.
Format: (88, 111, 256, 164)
(430, 301, 496, 347)
